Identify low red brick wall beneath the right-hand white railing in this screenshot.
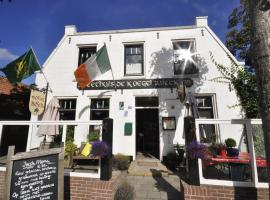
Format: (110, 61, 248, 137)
(181, 182, 269, 200)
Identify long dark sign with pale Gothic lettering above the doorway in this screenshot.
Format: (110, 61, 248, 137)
(85, 78, 193, 90)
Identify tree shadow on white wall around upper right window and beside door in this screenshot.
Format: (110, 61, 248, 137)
(147, 47, 208, 159)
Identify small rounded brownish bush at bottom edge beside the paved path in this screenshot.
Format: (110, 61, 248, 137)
(114, 182, 135, 200)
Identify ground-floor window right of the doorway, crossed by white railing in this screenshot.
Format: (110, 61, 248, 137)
(195, 95, 217, 142)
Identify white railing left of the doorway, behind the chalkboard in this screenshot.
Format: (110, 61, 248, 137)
(0, 120, 102, 178)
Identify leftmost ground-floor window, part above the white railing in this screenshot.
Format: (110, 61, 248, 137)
(59, 99, 76, 120)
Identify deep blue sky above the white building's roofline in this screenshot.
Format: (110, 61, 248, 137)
(0, 0, 239, 84)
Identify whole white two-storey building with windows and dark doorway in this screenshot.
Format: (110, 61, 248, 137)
(29, 17, 241, 159)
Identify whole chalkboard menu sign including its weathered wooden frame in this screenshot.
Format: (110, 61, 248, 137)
(7, 145, 63, 200)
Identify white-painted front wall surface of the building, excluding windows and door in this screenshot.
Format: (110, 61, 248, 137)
(32, 18, 241, 160)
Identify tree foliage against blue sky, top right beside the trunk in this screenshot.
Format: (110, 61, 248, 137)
(226, 0, 252, 67)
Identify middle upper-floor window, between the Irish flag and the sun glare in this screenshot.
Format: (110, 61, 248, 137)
(124, 45, 143, 76)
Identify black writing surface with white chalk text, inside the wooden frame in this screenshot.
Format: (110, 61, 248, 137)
(10, 154, 58, 200)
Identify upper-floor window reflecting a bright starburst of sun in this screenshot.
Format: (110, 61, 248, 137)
(173, 40, 199, 75)
